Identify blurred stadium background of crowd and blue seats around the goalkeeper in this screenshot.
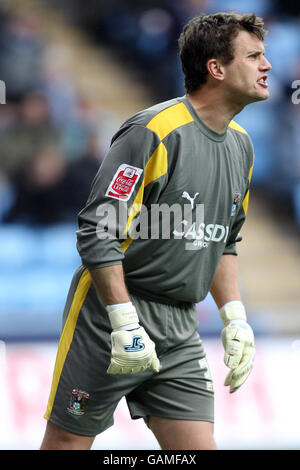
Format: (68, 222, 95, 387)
(0, 0, 300, 449)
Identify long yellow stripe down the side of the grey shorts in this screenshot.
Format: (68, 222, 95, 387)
(45, 269, 92, 419)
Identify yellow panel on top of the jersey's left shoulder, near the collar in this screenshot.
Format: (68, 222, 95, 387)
(146, 103, 194, 140)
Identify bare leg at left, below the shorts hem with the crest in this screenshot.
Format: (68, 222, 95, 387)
(40, 421, 95, 450)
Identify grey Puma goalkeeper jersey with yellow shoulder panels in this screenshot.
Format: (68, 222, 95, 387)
(77, 96, 254, 305)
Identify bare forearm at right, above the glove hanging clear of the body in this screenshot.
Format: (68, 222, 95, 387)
(210, 255, 241, 309)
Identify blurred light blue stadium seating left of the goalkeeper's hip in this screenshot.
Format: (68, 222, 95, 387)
(0, 224, 80, 339)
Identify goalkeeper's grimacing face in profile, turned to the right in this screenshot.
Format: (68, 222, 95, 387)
(223, 31, 272, 106)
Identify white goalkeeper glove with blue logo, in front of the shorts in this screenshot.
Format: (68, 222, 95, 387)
(106, 302, 159, 374)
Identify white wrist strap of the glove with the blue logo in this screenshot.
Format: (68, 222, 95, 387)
(106, 302, 139, 330)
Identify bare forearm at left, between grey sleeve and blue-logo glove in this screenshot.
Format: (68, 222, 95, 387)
(90, 264, 131, 306)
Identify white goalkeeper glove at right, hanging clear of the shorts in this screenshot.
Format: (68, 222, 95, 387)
(220, 300, 255, 393)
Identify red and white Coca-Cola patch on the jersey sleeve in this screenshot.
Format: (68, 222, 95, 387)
(105, 163, 143, 201)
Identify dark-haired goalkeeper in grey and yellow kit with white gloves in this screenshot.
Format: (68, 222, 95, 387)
(41, 13, 271, 450)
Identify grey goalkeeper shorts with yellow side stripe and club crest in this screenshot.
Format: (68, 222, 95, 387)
(45, 267, 214, 436)
